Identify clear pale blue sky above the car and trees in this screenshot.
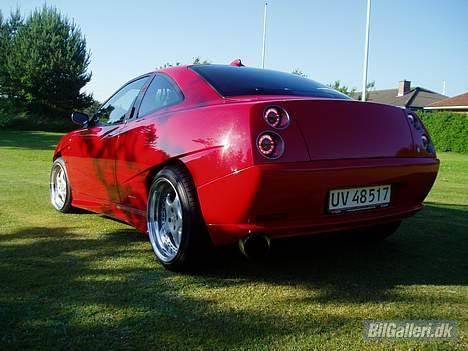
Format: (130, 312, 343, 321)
(0, 0, 468, 101)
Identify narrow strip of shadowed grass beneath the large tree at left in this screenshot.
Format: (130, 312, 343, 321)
(0, 130, 62, 150)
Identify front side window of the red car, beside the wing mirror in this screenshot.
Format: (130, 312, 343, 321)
(95, 77, 148, 124)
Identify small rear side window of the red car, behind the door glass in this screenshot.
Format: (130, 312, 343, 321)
(138, 74, 183, 117)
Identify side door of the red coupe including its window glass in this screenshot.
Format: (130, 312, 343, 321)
(68, 76, 148, 205)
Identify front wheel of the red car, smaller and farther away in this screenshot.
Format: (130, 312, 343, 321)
(49, 157, 72, 213)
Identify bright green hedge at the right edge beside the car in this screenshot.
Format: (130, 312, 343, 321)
(418, 112, 468, 154)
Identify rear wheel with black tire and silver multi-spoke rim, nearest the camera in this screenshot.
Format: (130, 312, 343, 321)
(147, 166, 209, 272)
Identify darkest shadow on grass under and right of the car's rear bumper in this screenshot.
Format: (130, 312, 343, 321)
(202, 204, 468, 294)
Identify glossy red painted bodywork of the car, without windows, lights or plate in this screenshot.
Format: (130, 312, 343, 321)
(54, 67, 439, 245)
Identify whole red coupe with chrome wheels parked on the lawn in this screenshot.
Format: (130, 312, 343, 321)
(50, 61, 439, 269)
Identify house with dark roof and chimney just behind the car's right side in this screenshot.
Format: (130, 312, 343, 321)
(358, 80, 447, 110)
